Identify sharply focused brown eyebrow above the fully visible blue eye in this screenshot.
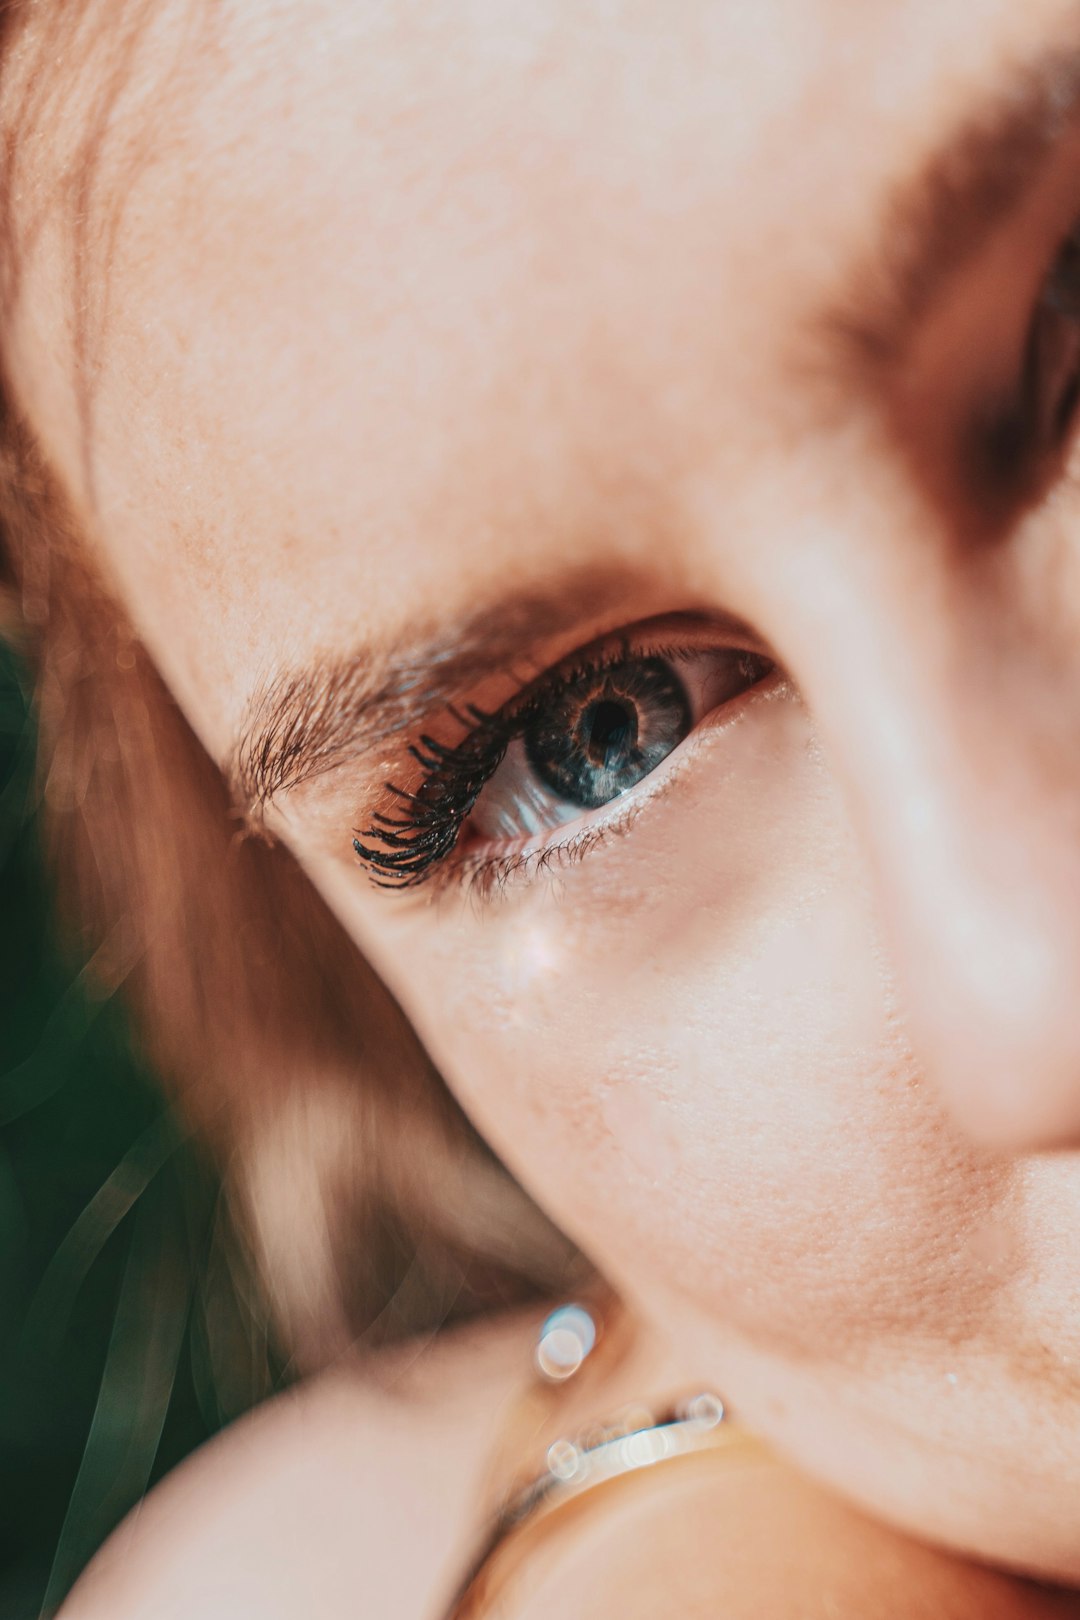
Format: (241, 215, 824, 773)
(227, 564, 641, 818)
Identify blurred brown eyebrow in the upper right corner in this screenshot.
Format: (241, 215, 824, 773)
(835, 29, 1080, 370)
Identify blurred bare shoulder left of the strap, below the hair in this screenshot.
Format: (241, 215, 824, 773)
(62, 1320, 533, 1620)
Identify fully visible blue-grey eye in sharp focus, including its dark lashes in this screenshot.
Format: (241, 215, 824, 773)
(353, 627, 776, 889)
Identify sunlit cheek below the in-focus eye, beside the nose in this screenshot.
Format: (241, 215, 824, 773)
(318, 700, 1009, 1356)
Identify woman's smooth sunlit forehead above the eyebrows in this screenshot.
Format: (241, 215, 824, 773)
(10, 0, 1074, 747)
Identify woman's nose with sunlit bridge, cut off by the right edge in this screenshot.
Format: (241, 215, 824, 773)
(751, 492, 1080, 1150)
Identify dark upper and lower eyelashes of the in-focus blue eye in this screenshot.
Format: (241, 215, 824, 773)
(353, 637, 767, 893)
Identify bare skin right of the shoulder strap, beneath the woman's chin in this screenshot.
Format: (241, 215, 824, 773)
(508, 1455, 1080, 1620)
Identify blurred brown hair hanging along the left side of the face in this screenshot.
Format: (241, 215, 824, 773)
(0, 6, 578, 1367)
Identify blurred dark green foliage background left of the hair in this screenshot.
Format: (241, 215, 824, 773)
(0, 645, 274, 1620)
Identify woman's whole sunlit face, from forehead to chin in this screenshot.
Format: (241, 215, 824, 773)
(8, 0, 1080, 1578)
